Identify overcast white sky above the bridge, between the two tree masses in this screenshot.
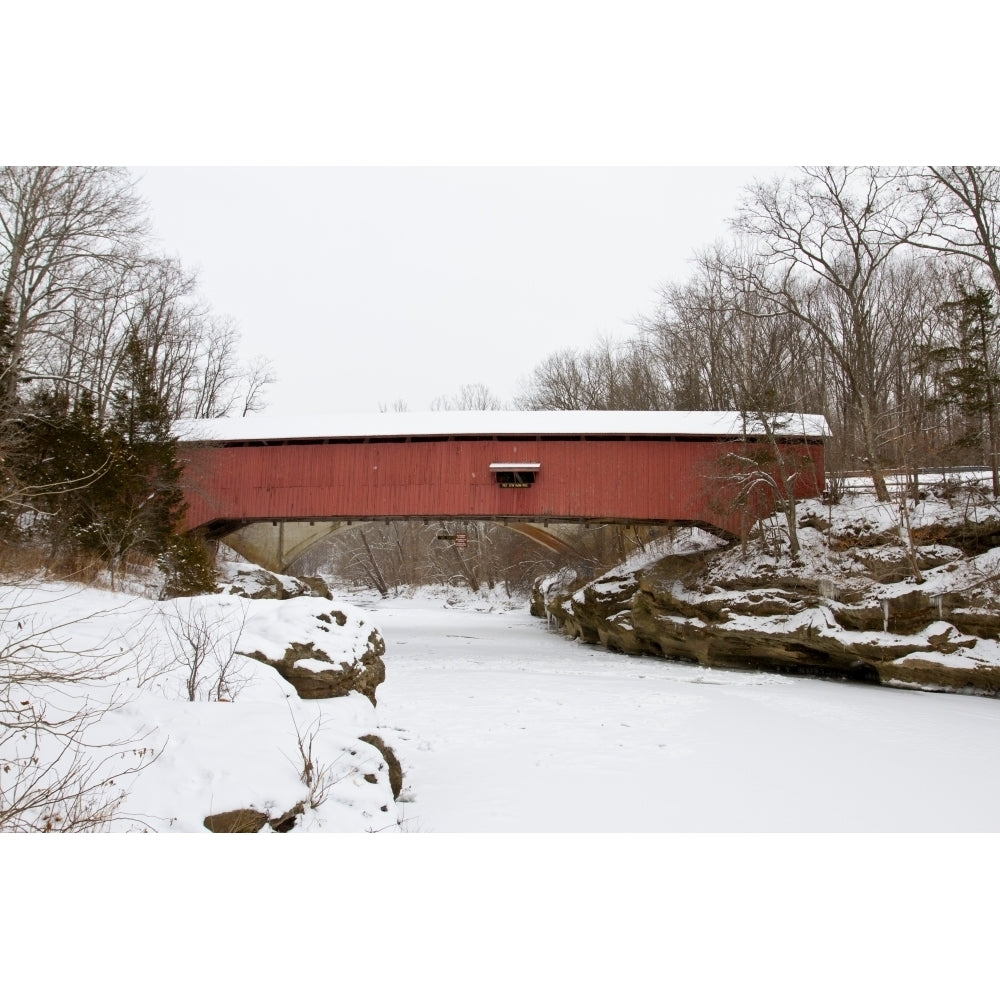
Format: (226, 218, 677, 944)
(134, 167, 778, 415)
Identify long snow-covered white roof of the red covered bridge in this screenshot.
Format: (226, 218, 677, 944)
(174, 410, 830, 442)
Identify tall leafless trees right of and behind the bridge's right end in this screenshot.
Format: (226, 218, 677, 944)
(515, 166, 1000, 508)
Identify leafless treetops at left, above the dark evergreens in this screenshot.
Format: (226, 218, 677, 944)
(0, 167, 274, 430)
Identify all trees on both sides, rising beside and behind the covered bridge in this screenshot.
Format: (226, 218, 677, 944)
(7, 166, 1000, 588)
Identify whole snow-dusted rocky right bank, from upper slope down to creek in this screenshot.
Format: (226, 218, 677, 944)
(533, 486, 1000, 695)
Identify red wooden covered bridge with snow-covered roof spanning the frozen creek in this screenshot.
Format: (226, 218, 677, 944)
(176, 410, 829, 569)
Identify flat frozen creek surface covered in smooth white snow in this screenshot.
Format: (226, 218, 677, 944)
(366, 595, 1000, 832)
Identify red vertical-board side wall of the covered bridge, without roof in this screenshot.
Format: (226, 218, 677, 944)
(180, 438, 825, 534)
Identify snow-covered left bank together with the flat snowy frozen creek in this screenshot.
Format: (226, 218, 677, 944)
(7, 586, 1000, 833)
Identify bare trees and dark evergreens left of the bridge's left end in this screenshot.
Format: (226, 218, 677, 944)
(0, 166, 274, 589)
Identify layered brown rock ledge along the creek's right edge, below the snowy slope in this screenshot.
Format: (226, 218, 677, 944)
(532, 524, 1000, 694)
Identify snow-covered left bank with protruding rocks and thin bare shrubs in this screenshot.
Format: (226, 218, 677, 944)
(0, 585, 399, 833)
